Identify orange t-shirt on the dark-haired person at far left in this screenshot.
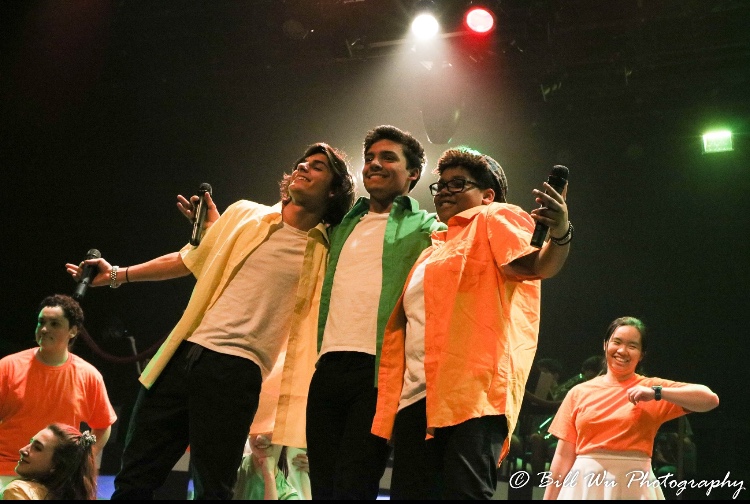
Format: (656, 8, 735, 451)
(0, 348, 117, 475)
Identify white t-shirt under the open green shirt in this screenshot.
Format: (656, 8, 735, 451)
(320, 213, 389, 355)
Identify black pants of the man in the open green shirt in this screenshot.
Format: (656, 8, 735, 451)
(307, 352, 390, 500)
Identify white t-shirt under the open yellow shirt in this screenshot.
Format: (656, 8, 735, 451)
(188, 223, 307, 378)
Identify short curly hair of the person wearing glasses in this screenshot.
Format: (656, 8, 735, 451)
(433, 146, 508, 203)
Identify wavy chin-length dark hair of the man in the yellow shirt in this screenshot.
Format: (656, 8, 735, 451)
(279, 142, 355, 226)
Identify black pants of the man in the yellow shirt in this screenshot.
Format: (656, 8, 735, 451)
(112, 342, 261, 500)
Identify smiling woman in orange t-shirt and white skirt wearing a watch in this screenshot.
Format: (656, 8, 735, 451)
(543, 317, 719, 500)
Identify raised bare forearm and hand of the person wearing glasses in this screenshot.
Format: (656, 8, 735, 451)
(506, 182, 572, 278)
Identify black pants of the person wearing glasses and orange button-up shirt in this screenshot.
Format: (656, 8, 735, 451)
(391, 399, 508, 500)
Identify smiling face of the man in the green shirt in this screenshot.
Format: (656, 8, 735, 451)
(362, 140, 419, 208)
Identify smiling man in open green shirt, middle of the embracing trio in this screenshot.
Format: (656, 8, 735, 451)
(307, 126, 442, 500)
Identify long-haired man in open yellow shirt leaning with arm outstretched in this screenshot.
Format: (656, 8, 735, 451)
(67, 144, 354, 500)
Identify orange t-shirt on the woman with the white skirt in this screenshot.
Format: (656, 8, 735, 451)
(549, 375, 687, 457)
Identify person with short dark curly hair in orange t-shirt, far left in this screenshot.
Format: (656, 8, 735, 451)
(0, 294, 117, 492)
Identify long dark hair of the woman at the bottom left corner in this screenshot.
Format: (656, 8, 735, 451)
(39, 423, 97, 500)
